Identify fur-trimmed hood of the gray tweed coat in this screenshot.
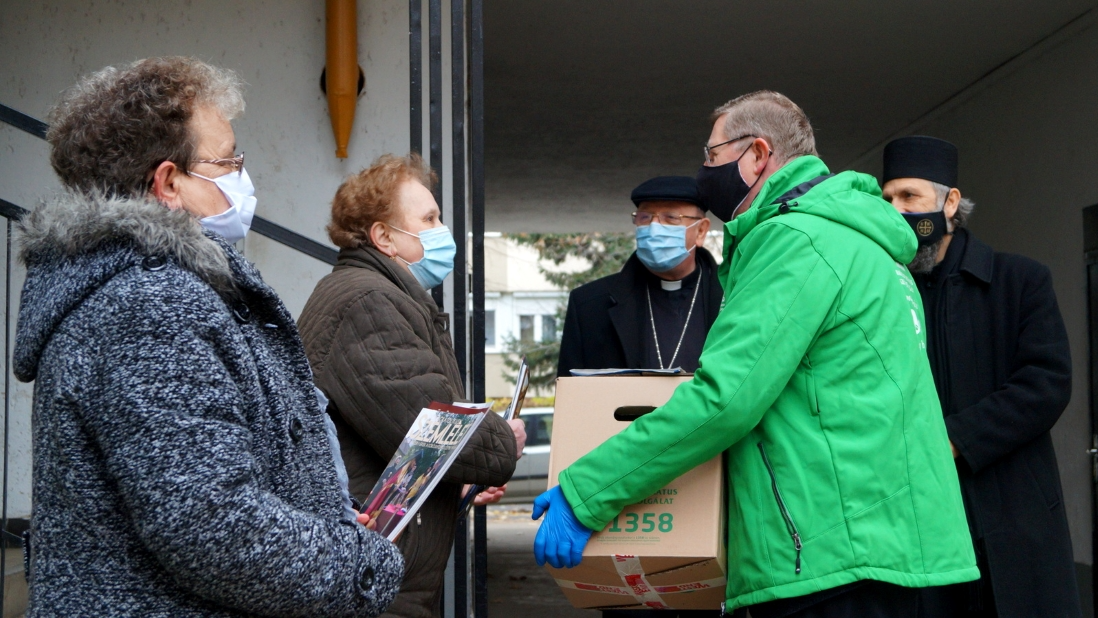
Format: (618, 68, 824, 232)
(13, 192, 236, 381)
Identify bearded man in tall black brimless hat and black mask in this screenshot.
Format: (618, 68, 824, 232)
(883, 136, 1080, 618)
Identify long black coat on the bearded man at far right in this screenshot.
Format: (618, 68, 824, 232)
(920, 229, 1080, 618)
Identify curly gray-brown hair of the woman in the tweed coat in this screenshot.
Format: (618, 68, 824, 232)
(46, 56, 244, 196)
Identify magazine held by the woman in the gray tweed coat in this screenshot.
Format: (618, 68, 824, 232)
(362, 402, 491, 541)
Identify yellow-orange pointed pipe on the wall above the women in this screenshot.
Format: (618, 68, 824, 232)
(325, 0, 359, 159)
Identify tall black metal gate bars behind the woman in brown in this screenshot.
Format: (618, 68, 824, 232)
(408, 0, 488, 618)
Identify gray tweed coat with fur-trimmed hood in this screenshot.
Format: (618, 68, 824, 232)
(14, 190, 403, 617)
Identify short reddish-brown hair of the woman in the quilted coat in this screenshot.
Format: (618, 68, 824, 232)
(328, 153, 438, 249)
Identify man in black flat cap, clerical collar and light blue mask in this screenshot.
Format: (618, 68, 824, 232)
(557, 176, 722, 375)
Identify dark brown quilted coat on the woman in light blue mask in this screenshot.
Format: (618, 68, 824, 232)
(299, 248, 517, 618)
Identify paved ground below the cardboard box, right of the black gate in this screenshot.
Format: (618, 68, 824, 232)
(488, 504, 601, 618)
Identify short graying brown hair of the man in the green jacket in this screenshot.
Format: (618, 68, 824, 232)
(713, 90, 816, 165)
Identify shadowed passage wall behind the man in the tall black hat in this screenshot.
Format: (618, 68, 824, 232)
(855, 16, 1098, 564)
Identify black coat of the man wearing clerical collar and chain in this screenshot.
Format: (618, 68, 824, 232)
(557, 247, 724, 377)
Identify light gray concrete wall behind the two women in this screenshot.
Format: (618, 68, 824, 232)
(0, 0, 419, 516)
